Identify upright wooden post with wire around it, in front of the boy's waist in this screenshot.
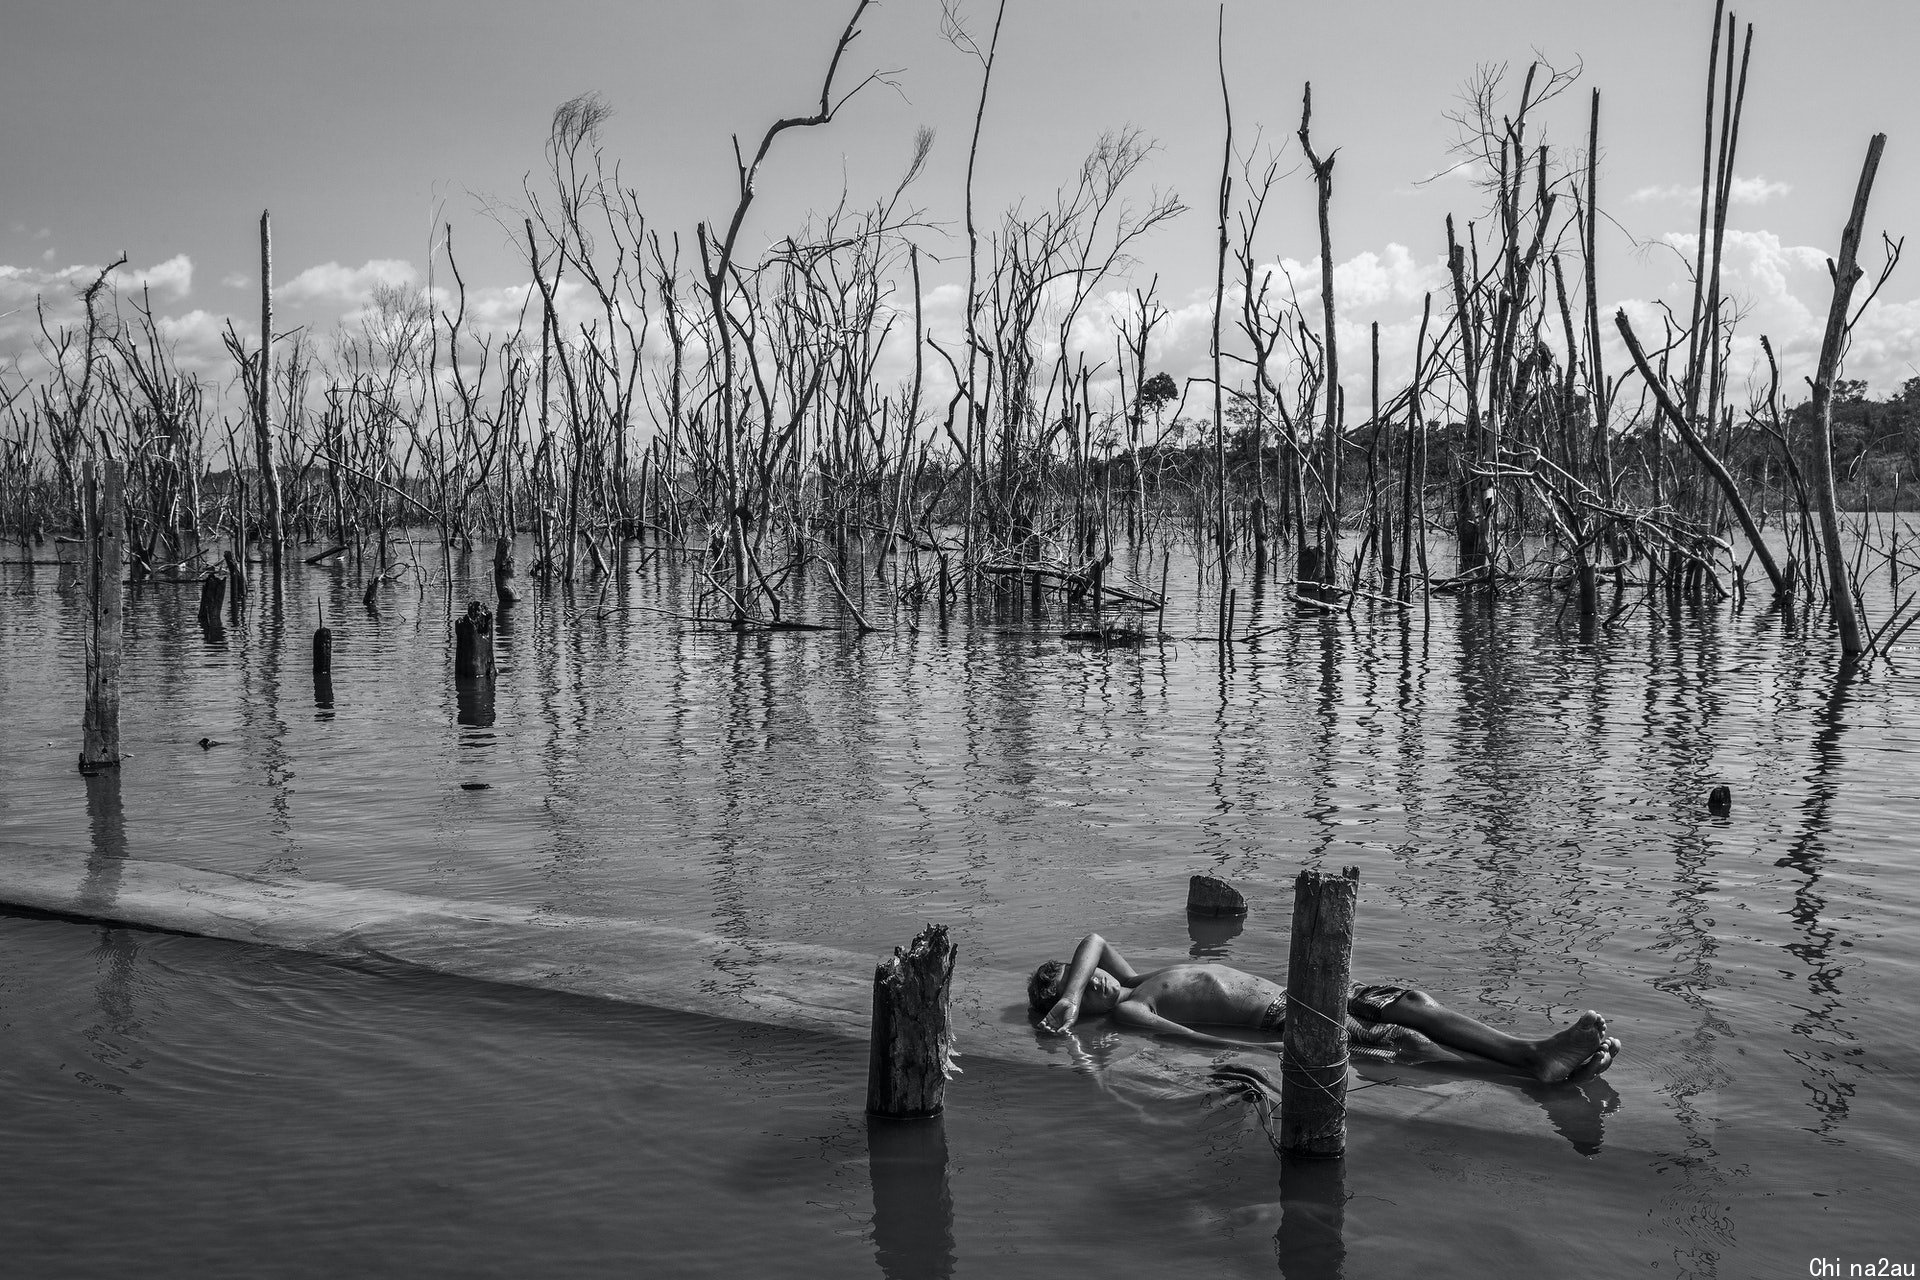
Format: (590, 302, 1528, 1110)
(1281, 867, 1359, 1157)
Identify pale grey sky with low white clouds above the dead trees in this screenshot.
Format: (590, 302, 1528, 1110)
(0, 0, 1920, 420)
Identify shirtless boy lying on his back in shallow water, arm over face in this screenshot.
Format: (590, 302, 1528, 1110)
(1027, 933, 1620, 1084)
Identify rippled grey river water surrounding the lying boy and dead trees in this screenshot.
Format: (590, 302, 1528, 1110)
(0, 529, 1920, 1276)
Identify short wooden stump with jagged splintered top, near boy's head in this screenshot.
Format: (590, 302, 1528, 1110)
(866, 925, 958, 1119)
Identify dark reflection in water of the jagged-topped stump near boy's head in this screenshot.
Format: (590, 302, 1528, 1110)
(866, 1115, 956, 1280)
